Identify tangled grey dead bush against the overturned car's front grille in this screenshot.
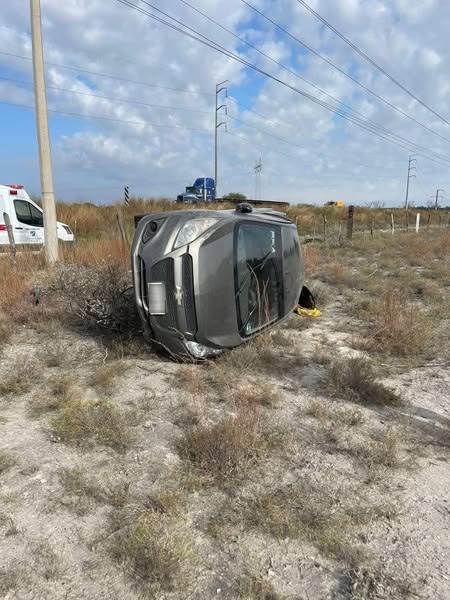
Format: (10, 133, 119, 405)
(46, 260, 141, 333)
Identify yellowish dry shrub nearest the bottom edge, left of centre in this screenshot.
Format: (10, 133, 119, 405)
(110, 502, 195, 597)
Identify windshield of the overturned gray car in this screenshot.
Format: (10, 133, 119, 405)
(235, 223, 282, 336)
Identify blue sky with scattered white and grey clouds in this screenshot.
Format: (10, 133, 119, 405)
(0, 0, 450, 205)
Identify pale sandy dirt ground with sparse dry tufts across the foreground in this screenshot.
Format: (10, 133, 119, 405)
(0, 231, 450, 600)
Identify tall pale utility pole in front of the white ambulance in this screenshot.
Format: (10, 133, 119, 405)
(30, 0, 58, 265)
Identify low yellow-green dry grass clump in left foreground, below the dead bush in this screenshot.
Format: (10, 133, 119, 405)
(51, 399, 133, 452)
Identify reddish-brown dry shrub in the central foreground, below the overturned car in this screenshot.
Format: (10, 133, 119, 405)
(178, 407, 270, 485)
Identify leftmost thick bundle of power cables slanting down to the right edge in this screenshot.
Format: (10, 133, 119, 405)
(110, 0, 449, 166)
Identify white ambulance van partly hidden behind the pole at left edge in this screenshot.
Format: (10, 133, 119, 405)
(0, 185, 74, 246)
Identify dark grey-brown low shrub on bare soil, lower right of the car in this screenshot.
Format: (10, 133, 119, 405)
(327, 358, 401, 406)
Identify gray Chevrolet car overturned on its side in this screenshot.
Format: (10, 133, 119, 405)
(132, 204, 304, 359)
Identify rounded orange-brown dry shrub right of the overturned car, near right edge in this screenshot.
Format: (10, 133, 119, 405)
(371, 290, 433, 356)
